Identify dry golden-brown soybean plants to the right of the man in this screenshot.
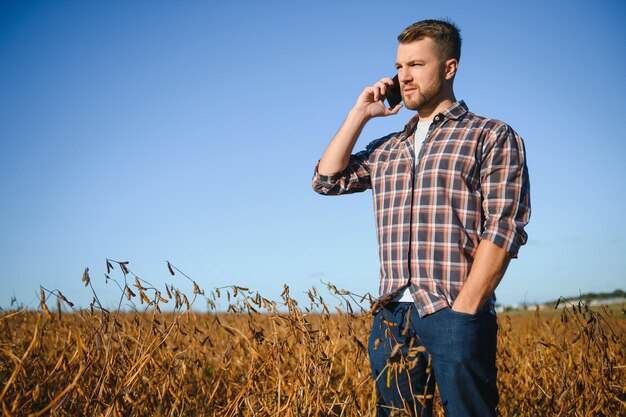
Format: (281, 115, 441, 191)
(498, 298, 626, 416)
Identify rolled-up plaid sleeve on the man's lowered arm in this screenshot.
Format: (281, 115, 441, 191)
(480, 125, 530, 258)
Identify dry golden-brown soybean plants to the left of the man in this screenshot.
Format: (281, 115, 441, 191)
(0, 259, 373, 416)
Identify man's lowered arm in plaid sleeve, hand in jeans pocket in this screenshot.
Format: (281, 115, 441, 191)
(452, 125, 530, 314)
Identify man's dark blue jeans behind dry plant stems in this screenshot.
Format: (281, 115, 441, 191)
(368, 303, 498, 417)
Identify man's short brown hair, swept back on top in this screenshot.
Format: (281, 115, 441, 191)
(398, 20, 461, 61)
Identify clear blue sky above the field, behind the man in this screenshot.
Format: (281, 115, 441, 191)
(0, 0, 626, 308)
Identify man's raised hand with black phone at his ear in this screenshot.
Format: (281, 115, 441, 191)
(354, 76, 402, 118)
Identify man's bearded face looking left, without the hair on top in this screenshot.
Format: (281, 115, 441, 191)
(396, 38, 446, 112)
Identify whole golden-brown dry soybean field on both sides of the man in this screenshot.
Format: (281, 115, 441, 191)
(0, 260, 626, 417)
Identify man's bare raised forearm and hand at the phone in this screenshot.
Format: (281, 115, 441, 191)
(317, 78, 402, 177)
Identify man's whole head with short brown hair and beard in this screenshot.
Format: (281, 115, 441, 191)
(396, 20, 461, 117)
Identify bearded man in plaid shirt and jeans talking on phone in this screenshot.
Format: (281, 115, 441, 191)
(313, 20, 530, 417)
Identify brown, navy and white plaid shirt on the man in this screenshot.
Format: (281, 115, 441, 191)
(313, 101, 530, 316)
